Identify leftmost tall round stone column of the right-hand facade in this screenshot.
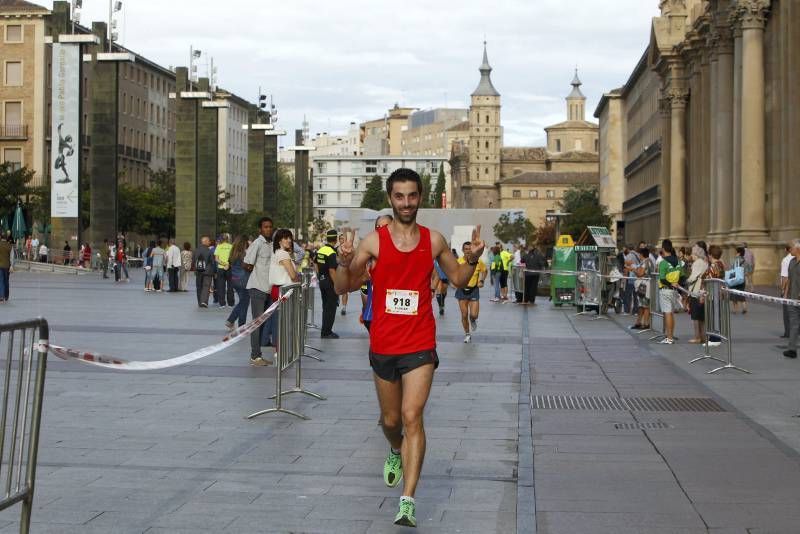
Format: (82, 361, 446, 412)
(669, 87, 689, 246)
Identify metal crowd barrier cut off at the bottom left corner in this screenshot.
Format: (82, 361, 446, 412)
(0, 319, 49, 533)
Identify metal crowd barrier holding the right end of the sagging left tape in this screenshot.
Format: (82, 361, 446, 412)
(247, 283, 325, 420)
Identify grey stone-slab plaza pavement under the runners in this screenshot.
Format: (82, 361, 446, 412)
(0, 270, 800, 534)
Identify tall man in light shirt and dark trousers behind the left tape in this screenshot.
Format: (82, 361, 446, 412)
(243, 217, 273, 366)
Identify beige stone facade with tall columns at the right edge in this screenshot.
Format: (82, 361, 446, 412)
(596, 0, 800, 283)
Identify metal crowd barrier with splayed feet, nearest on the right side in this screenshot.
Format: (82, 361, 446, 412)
(689, 278, 751, 374)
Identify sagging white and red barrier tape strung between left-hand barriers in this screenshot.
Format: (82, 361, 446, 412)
(47, 290, 294, 371)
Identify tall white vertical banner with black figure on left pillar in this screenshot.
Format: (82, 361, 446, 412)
(50, 43, 81, 217)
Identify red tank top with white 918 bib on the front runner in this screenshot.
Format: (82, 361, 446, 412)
(369, 226, 436, 356)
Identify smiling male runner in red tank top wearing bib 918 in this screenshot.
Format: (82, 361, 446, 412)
(335, 169, 484, 527)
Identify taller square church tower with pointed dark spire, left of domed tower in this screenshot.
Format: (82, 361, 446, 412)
(462, 41, 502, 208)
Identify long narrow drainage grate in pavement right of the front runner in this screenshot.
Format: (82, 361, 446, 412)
(531, 395, 725, 412)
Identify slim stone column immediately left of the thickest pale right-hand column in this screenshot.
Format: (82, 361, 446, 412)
(715, 28, 734, 239)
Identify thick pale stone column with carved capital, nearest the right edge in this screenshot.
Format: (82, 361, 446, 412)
(737, 0, 769, 236)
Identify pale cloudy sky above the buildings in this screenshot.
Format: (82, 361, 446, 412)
(40, 0, 659, 146)
